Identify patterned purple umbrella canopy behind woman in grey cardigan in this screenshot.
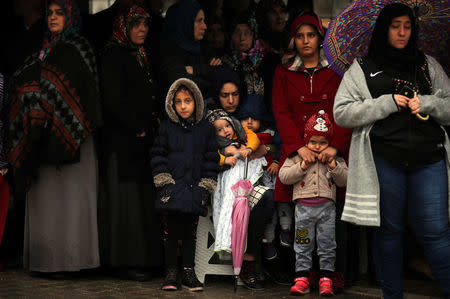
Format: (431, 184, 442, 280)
(323, 0, 450, 76)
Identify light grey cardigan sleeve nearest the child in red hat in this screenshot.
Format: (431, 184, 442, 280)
(333, 60, 398, 128)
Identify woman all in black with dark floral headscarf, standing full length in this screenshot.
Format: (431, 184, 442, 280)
(99, 6, 162, 280)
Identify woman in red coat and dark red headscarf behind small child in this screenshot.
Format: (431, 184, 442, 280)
(272, 13, 351, 290)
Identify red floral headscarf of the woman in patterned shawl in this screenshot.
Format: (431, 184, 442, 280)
(39, 0, 81, 61)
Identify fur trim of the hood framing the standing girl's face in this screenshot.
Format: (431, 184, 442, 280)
(165, 78, 204, 123)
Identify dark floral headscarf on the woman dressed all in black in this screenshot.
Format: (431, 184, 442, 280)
(112, 5, 150, 67)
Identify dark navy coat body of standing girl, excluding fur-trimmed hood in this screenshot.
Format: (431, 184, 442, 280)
(152, 119, 219, 216)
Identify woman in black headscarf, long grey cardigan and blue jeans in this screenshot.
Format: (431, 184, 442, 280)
(334, 3, 450, 298)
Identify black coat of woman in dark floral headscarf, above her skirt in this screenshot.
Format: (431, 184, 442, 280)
(100, 45, 162, 181)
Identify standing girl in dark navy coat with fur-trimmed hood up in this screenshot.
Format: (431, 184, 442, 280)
(151, 78, 219, 291)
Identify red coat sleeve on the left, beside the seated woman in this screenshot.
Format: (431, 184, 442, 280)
(272, 66, 305, 155)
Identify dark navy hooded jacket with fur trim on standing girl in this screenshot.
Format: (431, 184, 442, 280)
(151, 78, 219, 216)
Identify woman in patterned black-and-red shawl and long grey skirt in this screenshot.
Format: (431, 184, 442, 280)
(7, 0, 102, 273)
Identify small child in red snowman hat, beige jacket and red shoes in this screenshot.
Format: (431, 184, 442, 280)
(279, 110, 347, 296)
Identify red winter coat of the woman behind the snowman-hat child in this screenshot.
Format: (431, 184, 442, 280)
(272, 60, 351, 202)
